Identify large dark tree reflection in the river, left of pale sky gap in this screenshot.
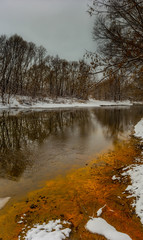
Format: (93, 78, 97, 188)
(0, 110, 92, 179)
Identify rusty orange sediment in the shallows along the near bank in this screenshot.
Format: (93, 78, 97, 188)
(0, 140, 143, 240)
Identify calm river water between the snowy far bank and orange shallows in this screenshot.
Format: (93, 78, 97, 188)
(0, 106, 143, 202)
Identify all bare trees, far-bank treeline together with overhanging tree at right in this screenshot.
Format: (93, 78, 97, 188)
(0, 0, 143, 103)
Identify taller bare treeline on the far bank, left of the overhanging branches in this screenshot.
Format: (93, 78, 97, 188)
(0, 35, 91, 103)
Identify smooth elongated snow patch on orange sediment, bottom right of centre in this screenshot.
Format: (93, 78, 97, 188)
(85, 217, 132, 240)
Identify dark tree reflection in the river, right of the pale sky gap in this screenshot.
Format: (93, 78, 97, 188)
(91, 106, 143, 142)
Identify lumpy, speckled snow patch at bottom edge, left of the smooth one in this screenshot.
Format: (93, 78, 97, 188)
(19, 219, 71, 240)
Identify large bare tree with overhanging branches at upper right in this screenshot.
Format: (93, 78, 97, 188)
(88, 0, 143, 100)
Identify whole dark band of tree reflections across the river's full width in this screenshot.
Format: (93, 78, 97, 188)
(0, 107, 143, 180)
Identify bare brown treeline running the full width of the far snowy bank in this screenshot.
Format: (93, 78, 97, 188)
(0, 29, 143, 103)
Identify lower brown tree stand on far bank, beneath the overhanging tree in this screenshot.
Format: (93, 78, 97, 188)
(92, 72, 143, 101)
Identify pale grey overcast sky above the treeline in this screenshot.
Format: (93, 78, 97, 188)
(0, 0, 95, 60)
